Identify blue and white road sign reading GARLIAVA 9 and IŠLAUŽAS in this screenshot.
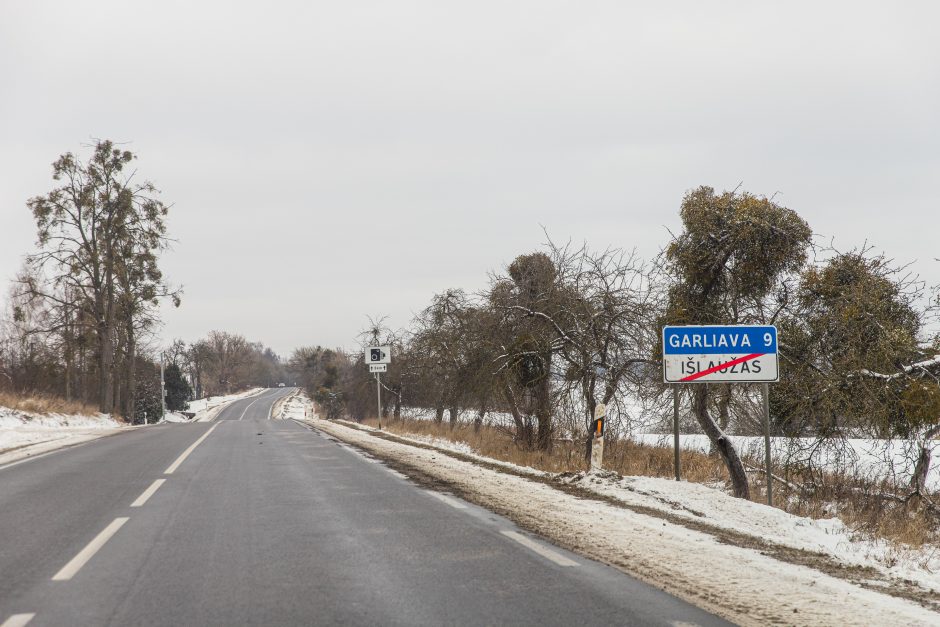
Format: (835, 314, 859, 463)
(663, 325, 779, 383)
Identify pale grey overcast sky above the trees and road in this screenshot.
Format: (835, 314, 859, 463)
(0, 0, 940, 356)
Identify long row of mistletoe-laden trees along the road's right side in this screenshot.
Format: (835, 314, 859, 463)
(289, 187, 940, 506)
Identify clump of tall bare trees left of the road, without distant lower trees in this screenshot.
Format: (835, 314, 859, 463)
(0, 141, 181, 416)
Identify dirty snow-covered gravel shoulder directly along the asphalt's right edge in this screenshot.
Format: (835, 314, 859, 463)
(305, 420, 938, 625)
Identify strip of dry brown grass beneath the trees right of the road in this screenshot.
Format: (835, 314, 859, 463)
(356, 418, 940, 548)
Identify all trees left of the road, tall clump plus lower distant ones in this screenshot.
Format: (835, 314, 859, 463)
(0, 141, 286, 422)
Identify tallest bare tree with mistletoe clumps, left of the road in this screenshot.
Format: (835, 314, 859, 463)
(25, 141, 174, 412)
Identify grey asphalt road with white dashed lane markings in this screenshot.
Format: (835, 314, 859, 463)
(0, 389, 724, 627)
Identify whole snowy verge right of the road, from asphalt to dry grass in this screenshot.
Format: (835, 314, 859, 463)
(310, 420, 940, 625)
